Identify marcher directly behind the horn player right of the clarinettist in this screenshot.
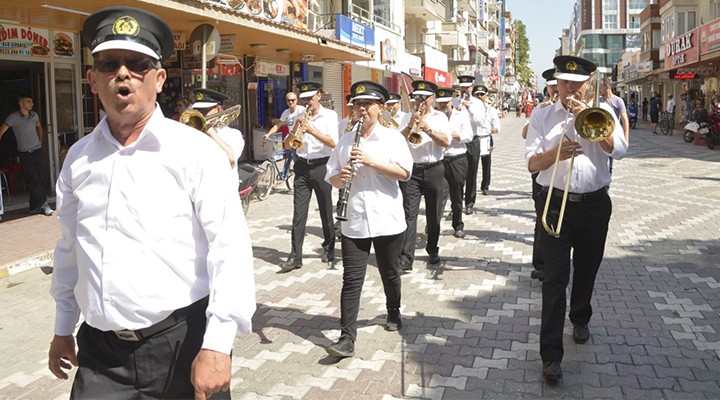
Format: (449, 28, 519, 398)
(435, 88, 473, 239)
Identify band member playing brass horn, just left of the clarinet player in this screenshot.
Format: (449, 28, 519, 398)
(280, 82, 338, 272)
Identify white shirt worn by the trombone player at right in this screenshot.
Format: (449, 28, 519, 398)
(525, 101, 627, 193)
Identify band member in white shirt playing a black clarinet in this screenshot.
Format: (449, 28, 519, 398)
(325, 81, 413, 357)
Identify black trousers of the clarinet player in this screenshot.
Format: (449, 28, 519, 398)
(340, 233, 403, 341)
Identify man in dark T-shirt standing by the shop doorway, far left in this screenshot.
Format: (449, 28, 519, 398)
(0, 94, 53, 215)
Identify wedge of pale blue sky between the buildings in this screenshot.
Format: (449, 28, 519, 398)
(505, 0, 575, 88)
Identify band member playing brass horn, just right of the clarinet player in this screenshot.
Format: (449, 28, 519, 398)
(399, 80, 452, 271)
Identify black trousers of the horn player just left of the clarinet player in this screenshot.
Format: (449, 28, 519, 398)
(290, 158, 335, 259)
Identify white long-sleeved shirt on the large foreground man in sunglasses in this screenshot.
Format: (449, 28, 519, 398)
(51, 105, 255, 354)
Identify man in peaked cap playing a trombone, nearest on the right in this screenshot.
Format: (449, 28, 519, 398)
(525, 56, 627, 381)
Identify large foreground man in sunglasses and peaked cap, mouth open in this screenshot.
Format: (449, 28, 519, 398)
(48, 7, 255, 398)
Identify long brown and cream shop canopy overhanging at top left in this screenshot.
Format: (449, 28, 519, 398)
(0, 0, 373, 62)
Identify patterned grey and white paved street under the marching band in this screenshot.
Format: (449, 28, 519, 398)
(0, 116, 720, 399)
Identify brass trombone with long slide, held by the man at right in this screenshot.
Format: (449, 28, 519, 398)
(542, 72, 615, 238)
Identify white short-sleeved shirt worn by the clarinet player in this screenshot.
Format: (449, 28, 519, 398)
(325, 123, 413, 239)
